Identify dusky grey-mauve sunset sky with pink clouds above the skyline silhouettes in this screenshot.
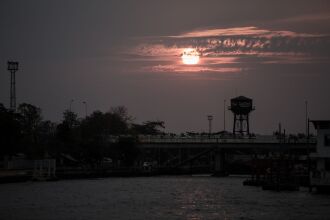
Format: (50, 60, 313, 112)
(0, 0, 330, 134)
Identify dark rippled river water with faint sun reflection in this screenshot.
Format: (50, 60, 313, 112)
(0, 176, 330, 220)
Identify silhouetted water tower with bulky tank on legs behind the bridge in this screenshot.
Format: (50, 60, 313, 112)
(228, 96, 254, 135)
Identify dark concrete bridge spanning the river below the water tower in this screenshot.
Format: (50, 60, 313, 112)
(127, 136, 316, 174)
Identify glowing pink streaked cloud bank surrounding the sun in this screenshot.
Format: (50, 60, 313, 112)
(126, 26, 330, 73)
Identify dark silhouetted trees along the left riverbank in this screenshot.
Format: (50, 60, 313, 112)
(0, 103, 164, 166)
